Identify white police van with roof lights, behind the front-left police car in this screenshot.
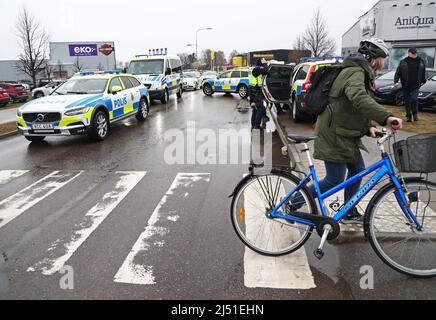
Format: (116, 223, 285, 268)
(127, 54, 183, 104)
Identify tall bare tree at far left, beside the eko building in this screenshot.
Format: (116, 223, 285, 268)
(16, 7, 49, 87)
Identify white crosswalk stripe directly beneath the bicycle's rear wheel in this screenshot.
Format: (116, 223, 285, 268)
(244, 178, 316, 290)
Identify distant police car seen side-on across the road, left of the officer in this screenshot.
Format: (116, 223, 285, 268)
(203, 69, 251, 99)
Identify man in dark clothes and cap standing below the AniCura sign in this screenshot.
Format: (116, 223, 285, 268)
(394, 48, 427, 122)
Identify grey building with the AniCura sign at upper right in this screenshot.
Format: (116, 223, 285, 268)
(342, 0, 436, 70)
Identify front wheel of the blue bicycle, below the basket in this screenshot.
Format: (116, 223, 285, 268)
(365, 178, 436, 278)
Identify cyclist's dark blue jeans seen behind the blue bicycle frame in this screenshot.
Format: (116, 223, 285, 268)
(291, 153, 365, 215)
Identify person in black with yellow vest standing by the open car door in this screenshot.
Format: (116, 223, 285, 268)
(249, 59, 268, 129)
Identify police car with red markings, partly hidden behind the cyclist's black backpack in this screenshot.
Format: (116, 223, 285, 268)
(290, 57, 343, 123)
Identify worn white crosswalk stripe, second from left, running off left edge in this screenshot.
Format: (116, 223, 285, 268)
(0, 171, 83, 228)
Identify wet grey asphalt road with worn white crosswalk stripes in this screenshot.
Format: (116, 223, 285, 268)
(0, 92, 436, 300)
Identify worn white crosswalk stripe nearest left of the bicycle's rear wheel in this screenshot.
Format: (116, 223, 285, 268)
(114, 173, 210, 285)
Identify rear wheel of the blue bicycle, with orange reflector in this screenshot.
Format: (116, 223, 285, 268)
(231, 172, 317, 257)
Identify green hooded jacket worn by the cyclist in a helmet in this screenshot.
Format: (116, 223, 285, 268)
(314, 54, 392, 164)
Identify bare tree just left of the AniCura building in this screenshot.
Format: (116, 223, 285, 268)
(302, 8, 336, 57)
